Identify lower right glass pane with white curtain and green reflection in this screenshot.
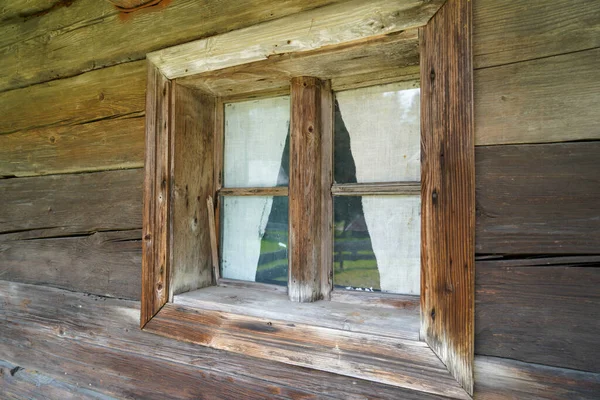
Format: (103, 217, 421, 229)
(333, 195, 421, 294)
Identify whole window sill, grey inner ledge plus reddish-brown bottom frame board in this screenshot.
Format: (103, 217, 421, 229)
(144, 285, 470, 399)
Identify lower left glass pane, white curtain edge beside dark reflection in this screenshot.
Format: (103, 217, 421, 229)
(221, 196, 288, 286)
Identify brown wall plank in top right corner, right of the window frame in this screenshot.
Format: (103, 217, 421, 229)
(473, 0, 600, 69)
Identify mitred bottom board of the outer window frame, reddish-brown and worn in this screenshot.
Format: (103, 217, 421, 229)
(144, 303, 470, 399)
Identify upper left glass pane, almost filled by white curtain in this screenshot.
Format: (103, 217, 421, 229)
(223, 96, 290, 188)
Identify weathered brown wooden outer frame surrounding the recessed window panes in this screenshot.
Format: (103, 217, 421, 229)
(141, 0, 475, 398)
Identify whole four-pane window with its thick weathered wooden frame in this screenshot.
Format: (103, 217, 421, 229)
(141, 0, 474, 398)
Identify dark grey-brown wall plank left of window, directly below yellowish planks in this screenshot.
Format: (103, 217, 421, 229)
(0, 169, 142, 241)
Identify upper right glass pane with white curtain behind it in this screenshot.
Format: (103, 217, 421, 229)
(334, 83, 421, 183)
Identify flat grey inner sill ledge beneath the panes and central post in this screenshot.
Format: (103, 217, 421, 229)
(173, 286, 420, 340)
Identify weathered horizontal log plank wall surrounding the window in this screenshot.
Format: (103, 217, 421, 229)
(0, 0, 600, 399)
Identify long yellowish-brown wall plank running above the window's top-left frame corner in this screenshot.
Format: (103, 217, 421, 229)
(0, 0, 346, 90)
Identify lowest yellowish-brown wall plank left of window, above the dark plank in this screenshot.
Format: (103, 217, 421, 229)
(0, 116, 144, 177)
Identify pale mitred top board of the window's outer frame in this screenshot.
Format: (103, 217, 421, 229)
(148, 0, 443, 79)
